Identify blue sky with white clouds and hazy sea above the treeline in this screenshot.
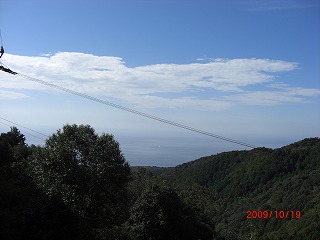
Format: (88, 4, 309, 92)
(0, 0, 320, 166)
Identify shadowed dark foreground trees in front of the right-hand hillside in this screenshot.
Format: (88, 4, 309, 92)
(0, 125, 220, 240)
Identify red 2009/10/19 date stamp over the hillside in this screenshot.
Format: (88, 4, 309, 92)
(247, 210, 301, 219)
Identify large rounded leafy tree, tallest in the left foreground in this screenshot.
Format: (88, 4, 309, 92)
(28, 124, 130, 231)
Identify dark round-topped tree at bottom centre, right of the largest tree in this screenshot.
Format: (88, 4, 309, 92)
(130, 185, 213, 240)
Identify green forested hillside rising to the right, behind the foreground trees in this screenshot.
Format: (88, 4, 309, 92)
(159, 138, 320, 239)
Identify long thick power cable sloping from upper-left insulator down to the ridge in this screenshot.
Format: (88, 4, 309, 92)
(0, 62, 257, 148)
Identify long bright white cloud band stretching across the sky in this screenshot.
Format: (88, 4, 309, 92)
(0, 52, 320, 110)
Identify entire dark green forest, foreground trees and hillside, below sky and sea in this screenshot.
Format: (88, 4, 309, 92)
(0, 125, 320, 240)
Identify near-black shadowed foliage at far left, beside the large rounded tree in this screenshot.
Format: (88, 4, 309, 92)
(0, 128, 88, 240)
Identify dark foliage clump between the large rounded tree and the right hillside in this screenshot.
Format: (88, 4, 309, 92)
(128, 168, 221, 239)
